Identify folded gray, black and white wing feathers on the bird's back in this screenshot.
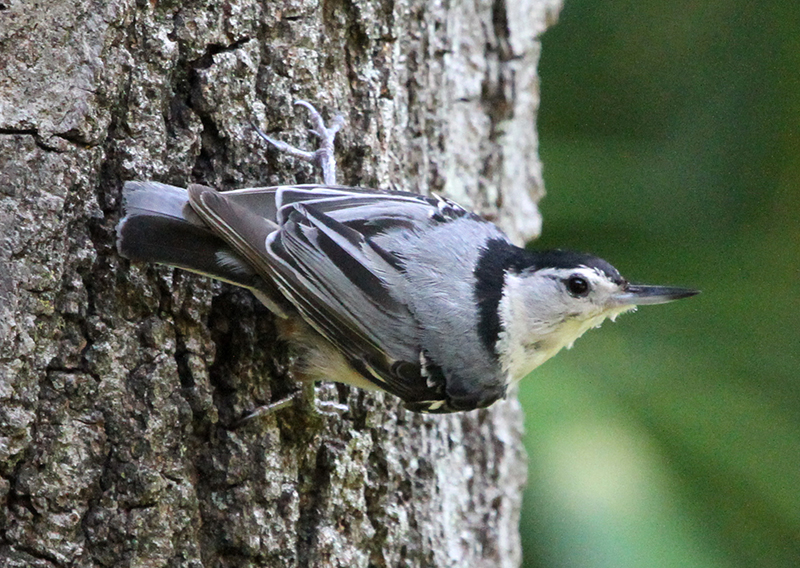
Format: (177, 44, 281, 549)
(189, 186, 466, 404)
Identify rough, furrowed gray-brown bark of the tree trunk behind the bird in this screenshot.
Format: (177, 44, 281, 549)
(0, 0, 557, 567)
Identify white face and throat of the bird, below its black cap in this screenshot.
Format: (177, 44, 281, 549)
(497, 267, 635, 381)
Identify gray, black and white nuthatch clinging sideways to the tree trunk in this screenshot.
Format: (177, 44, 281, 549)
(117, 101, 697, 412)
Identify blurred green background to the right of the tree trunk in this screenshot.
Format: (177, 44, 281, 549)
(520, 0, 800, 568)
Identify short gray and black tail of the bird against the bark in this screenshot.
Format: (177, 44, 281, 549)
(117, 181, 259, 289)
